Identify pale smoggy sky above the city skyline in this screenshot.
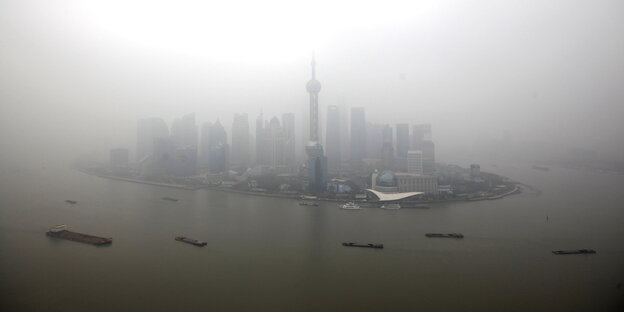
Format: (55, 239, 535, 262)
(0, 0, 624, 166)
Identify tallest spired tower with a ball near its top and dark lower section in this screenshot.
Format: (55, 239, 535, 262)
(306, 58, 327, 192)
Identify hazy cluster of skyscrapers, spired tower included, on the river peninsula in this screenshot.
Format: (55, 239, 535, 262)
(110, 56, 438, 195)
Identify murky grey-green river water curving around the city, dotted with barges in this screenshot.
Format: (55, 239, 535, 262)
(0, 165, 624, 311)
